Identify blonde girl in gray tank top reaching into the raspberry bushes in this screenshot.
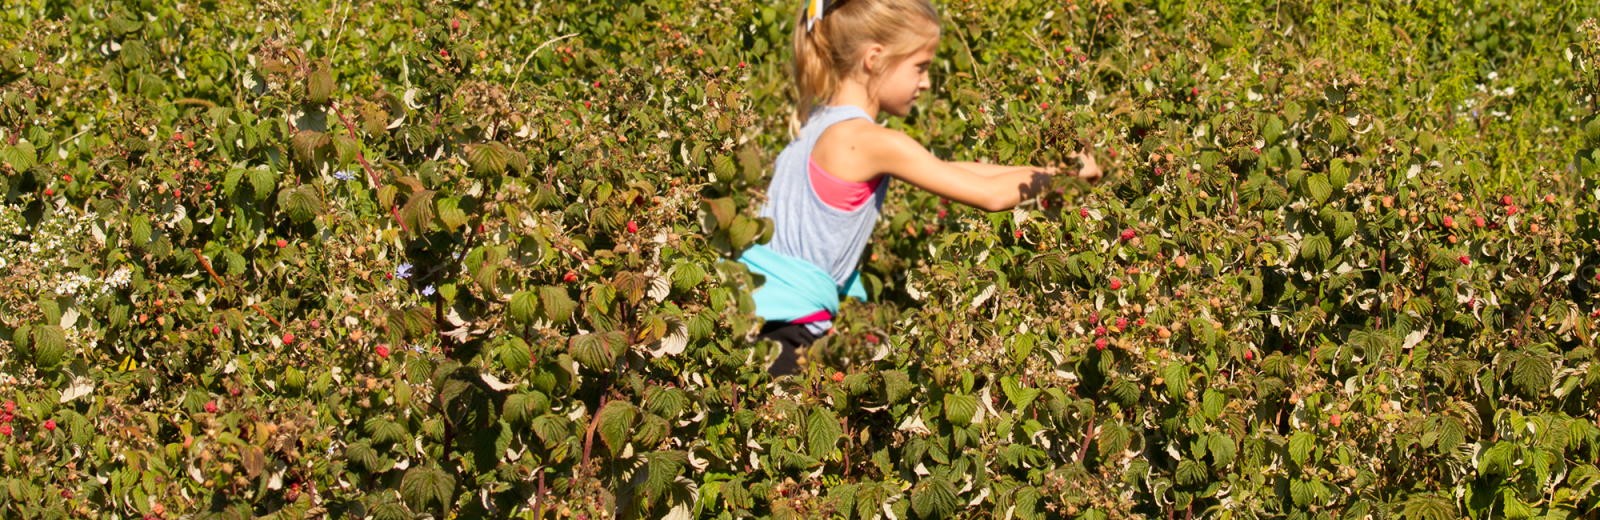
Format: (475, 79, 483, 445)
(741, 0, 1101, 376)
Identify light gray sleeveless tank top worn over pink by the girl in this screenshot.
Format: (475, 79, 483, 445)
(760, 106, 890, 323)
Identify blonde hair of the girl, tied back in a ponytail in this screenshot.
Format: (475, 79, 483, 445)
(794, 0, 939, 125)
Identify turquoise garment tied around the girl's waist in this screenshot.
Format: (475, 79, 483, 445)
(739, 245, 867, 322)
